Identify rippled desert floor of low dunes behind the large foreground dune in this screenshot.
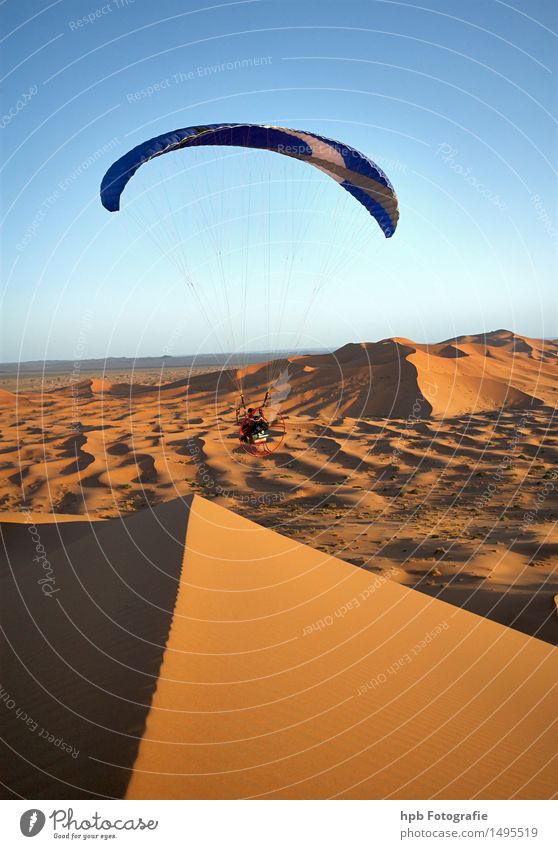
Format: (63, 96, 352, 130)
(0, 334, 558, 643)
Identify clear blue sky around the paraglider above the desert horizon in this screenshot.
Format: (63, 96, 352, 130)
(0, 0, 558, 361)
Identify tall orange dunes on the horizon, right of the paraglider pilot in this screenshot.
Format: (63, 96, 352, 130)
(225, 330, 558, 418)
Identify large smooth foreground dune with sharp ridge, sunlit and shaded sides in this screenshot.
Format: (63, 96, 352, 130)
(2, 497, 558, 799)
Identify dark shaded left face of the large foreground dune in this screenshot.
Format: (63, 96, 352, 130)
(0, 499, 191, 799)
